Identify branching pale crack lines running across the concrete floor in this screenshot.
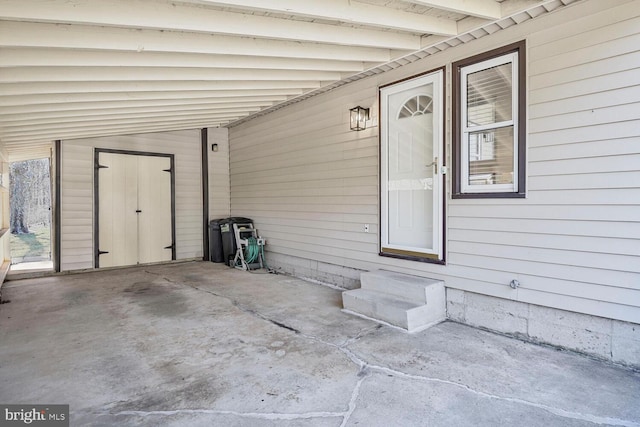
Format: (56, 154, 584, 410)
(160, 284, 640, 427)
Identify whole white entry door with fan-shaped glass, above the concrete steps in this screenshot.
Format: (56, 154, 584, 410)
(380, 71, 443, 260)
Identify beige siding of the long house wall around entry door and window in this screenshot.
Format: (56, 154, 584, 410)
(230, 0, 640, 323)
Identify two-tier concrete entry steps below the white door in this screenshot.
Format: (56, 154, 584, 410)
(342, 270, 446, 332)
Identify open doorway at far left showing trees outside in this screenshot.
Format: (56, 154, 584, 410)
(9, 158, 53, 271)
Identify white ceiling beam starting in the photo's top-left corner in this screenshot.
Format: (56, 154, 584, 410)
(0, 0, 428, 50)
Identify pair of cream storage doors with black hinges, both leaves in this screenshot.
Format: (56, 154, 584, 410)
(95, 151, 175, 267)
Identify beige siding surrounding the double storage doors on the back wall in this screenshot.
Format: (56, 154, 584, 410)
(61, 130, 202, 271)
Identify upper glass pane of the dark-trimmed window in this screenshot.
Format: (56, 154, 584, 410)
(467, 63, 513, 127)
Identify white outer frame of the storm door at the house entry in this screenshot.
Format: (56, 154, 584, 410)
(380, 69, 445, 263)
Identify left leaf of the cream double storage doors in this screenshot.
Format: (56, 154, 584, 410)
(97, 153, 138, 267)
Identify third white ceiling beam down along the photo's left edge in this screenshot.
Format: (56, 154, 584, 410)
(0, 47, 364, 73)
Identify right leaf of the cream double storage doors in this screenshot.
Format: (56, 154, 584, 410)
(136, 156, 172, 263)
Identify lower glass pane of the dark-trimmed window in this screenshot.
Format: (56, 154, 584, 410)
(467, 126, 513, 185)
